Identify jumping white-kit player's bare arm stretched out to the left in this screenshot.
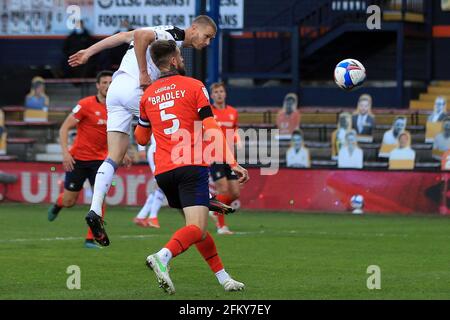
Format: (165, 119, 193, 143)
(68, 30, 135, 67)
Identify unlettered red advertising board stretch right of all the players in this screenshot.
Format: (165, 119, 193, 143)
(240, 168, 447, 214)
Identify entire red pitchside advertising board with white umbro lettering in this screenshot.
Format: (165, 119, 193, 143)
(0, 162, 449, 214)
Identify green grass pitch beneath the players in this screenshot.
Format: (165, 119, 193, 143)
(0, 203, 450, 300)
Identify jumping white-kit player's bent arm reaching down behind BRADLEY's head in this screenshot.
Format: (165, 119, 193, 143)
(134, 29, 156, 90)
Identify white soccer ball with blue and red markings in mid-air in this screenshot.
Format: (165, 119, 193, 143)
(334, 59, 366, 91)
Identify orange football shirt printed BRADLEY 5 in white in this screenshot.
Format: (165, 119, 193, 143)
(139, 75, 210, 175)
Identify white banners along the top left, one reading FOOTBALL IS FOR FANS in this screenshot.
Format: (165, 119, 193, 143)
(0, 0, 244, 36)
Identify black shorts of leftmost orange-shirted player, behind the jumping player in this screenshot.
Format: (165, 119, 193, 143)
(64, 159, 103, 192)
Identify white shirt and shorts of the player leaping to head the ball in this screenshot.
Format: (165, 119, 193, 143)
(106, 26, 184, 134)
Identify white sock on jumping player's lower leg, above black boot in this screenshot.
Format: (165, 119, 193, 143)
(91, 158, 118, 217)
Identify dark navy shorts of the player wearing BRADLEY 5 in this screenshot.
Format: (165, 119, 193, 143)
(155, 166, 209, 209)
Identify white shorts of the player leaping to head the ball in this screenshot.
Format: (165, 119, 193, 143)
(106, 70, 143, 134)
